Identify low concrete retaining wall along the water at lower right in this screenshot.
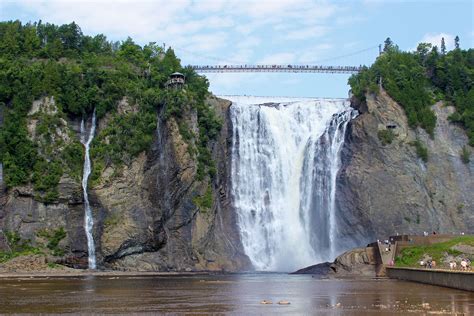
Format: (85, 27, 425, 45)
(387, 267, 474, 292)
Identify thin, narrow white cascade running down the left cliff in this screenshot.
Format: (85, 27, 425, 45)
(81, 110, 96, 269)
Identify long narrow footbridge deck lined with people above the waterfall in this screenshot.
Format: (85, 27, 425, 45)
(191, 65, 363, 74)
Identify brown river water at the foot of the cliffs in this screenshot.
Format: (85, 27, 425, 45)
(0, 273, 474, 315)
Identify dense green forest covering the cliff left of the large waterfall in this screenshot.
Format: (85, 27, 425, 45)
(0, 21, 221, 203)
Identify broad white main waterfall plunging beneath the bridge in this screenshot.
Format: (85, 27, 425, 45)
(230, 97, 354, 271)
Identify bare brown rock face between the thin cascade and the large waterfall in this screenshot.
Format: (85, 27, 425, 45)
(91, 99, 251, 271)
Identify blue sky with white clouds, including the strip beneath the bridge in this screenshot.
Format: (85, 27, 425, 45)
(0, 0, 474, 97)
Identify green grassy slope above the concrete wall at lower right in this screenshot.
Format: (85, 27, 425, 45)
(395, 236, 474, 267)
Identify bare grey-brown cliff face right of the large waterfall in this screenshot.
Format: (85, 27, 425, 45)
(337, 91, 474, 241)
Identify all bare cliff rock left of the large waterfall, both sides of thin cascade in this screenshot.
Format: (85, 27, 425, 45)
(0, 98, 251, 271)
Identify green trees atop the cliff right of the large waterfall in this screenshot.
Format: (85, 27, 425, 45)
(349, 37, 474, 146)
